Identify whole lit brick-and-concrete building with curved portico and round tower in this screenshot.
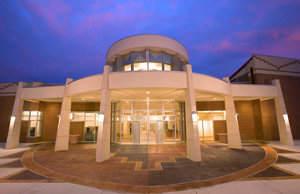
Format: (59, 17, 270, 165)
(0, 35, 300, 162)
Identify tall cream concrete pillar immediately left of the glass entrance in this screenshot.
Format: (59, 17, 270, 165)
(96, 65, 112, 162)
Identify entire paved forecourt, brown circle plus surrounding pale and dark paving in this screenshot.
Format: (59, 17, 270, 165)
(0, 142, 300, 193)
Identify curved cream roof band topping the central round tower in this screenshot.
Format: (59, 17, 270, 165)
(106, 34, 189, 62)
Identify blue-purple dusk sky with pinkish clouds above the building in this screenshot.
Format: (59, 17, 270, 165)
(0, 0, 300, 83)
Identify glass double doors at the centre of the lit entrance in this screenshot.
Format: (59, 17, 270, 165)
(140, 121, 157, 144)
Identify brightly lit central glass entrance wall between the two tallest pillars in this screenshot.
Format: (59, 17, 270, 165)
(111, 100, 185, 144)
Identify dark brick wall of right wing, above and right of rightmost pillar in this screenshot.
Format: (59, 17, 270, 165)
(256, 74, 300, 139)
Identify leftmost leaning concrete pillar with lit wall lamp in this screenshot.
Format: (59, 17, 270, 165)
(5, 82, 24, 149)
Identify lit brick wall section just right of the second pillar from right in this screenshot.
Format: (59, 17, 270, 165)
(234, 100, 256, 140)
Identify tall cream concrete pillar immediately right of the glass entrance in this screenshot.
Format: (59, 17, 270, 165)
(184, 64, 201, 161)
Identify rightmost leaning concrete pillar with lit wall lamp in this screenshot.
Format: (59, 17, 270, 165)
(272, 79, 294, 145)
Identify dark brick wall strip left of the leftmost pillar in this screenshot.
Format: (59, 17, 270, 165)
(0, 96, 15, 142)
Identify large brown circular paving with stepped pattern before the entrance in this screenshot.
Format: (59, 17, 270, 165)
(22, 142, 277, 193)
